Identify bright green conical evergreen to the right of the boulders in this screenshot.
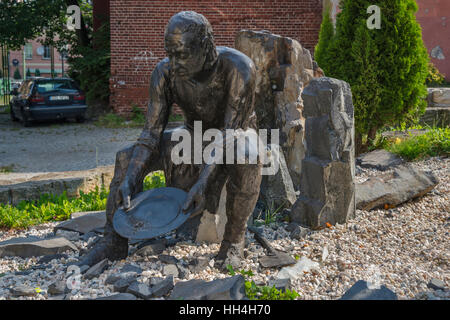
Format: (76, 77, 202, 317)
(316, 0, 429, 153)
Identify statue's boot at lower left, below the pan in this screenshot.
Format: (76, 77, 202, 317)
(77, 230, 128, 267)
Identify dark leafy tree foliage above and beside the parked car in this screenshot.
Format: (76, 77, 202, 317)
(0, 0, 110, 105)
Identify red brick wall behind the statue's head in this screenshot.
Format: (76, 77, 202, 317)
(110, 0, 322, 115)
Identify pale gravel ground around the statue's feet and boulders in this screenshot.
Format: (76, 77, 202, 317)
(0, 158, 450, 300)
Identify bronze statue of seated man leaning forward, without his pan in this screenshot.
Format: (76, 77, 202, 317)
(79, 11, 261, 268)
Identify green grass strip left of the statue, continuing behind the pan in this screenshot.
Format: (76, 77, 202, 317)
(0, 171, 165, 229)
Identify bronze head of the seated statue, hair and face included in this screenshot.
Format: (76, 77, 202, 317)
(164, 11, 217, 79)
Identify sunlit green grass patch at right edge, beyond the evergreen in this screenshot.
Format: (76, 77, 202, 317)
(385, 128, 450, 161)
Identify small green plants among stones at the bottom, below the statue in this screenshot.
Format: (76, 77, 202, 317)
(227, 265, 300, 300)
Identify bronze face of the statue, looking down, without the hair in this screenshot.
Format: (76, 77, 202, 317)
(165, 30, 206, 80)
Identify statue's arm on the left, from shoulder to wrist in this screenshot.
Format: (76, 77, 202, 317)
(121, 59, 172, 196)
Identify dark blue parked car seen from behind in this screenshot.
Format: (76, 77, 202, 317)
(10, 78, 87, 127)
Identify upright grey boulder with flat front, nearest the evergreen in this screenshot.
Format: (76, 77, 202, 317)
(290, 77, 355, 229)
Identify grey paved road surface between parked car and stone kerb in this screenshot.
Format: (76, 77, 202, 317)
(0, 114, 141, 172)
